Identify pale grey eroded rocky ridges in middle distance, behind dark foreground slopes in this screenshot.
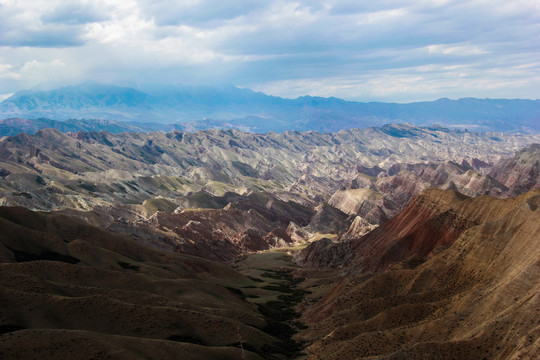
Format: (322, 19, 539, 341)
(0, 124, 540, 261)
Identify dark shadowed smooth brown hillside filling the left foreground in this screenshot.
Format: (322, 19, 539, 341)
(0, 207, 300, 359)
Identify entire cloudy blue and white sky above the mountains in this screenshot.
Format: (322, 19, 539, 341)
(0, 0, 540, 102)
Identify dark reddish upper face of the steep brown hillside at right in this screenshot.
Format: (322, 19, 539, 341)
(301, 188, 532, 272)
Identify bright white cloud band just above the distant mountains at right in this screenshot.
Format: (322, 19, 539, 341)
(245, 60, 540, 102)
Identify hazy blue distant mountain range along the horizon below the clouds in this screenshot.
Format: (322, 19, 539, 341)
(0, 83, 540, 135)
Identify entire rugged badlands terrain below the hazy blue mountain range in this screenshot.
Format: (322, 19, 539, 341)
(0, 124, 540, 359)
